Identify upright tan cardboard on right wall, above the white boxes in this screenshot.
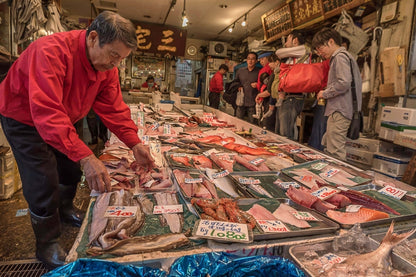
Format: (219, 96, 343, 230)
(379, 47, 406, 97)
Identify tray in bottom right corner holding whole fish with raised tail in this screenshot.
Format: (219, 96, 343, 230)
(289, 222, 416, 277)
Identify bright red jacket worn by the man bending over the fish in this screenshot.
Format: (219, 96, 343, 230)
(0, 30, 140, 161)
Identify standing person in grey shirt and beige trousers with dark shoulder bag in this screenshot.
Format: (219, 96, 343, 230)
(312, 28, 362, 160)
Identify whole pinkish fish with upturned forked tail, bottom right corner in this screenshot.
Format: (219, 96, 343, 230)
(321, 222, 416, 277)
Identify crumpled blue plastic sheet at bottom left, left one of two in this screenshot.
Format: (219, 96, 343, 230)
(43, 259, 166, 277)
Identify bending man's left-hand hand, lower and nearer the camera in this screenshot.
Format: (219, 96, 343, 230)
(80, 154, 111, 192)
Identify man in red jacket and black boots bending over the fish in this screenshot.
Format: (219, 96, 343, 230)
(0, 11, 154, 268)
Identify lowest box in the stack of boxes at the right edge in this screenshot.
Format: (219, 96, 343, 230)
(373, 152, 411, 177)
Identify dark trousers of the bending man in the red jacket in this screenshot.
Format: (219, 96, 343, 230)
(0, 115, 82, 217)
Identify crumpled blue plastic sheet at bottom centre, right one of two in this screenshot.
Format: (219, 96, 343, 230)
(168, 252, 305, 277)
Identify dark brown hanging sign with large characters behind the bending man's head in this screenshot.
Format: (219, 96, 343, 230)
(135, 23, 186, 56)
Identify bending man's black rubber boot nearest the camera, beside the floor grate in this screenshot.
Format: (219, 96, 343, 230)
(30, 211, 66, 269)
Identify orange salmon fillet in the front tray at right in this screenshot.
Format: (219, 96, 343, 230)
(326, 207, 389, 224)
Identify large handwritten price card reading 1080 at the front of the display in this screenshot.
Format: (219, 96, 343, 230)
(194, 219, 253, 240)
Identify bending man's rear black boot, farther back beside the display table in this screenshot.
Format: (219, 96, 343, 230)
(59, 184, 84, 227)
